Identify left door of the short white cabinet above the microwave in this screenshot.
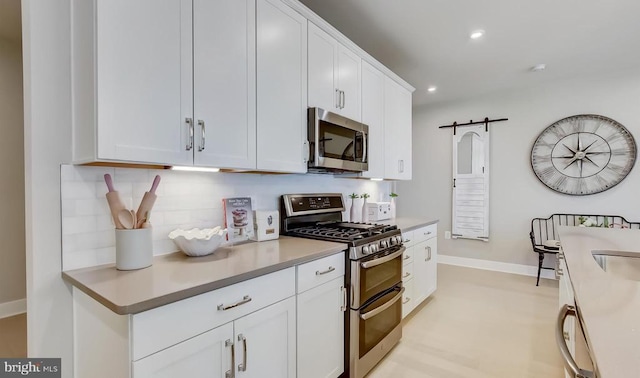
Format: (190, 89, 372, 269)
(308, 22, 340, 113)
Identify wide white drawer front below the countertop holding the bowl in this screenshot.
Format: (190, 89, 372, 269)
(131, 268, 295, 361)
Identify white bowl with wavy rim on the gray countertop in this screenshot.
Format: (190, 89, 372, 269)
(169, 226, 227, 257)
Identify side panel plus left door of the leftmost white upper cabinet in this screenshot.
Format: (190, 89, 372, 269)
(72, 0, 192, 164)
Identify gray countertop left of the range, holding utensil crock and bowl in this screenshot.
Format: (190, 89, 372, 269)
(62, 236, 347, 315)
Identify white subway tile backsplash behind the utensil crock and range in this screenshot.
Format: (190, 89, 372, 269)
(60, 165, 391, 270)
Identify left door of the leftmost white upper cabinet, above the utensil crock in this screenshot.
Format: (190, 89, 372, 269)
(95, 0, 193, 165)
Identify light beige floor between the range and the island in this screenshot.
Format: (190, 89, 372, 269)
(367, 264, 564, 378)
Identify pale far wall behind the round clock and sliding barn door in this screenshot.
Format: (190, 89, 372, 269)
(397, 72, 640, 266)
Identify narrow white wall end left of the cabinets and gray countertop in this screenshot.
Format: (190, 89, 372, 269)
(22, 0, 73, 378)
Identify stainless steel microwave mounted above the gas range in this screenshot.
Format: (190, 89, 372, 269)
(308, 108, 369, 172)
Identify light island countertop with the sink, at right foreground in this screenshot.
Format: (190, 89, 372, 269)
(559, 227, 640, 378)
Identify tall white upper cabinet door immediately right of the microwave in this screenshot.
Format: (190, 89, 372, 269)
(362, 62, 385, 178)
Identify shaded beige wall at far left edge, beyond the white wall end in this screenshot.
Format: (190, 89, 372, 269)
(0, 38, 26, 317)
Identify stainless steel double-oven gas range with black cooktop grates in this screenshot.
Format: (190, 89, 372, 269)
(282, 193, 405, 378)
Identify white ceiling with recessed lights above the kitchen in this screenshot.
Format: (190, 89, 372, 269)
(300, 0, 640, 106)
